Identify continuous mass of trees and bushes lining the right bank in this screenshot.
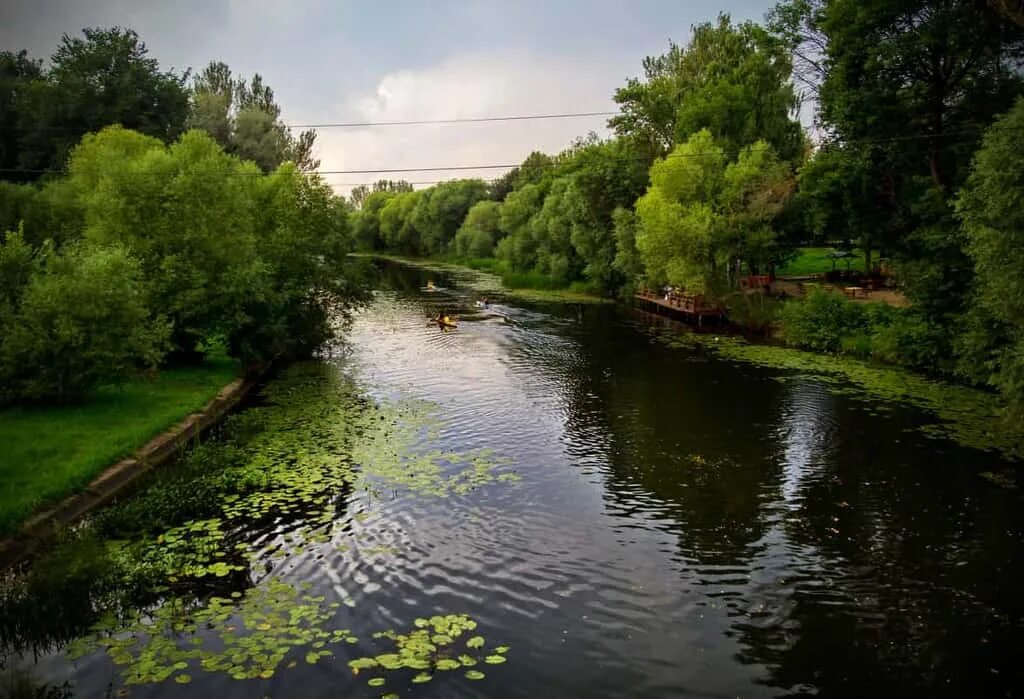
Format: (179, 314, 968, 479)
(342, 0, 1024, 421)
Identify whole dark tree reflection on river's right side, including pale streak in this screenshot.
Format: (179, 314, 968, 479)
(544, 310, 1024, 696)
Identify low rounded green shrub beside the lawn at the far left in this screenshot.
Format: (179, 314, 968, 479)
(0, 247, 169, 401)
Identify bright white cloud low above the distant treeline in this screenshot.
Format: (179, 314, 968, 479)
(317, 50, 633, 193)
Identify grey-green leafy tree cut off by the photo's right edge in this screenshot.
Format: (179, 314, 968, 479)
(956, 98, 1024, 420)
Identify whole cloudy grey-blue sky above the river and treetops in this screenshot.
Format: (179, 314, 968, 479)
(0, 0, 773, 193)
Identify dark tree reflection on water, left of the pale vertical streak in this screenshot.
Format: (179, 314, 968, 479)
(552, 309, 780, 566)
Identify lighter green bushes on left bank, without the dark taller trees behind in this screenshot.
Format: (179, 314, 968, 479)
(0, 122, 362, 400)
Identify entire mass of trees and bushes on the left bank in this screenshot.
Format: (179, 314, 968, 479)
(0, 28, 368, 402)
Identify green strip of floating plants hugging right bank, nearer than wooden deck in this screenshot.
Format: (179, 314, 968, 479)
(654, 330, 1024, 460)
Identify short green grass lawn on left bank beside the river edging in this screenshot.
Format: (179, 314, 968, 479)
(0, 356, 239, 534)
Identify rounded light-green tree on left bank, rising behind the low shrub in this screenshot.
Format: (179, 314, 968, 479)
(69, 127, 266, 358)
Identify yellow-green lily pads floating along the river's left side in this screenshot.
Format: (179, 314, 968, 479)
(48, 364, 517, 686)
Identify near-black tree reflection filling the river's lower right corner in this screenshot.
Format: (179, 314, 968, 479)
(734, 384, 1021, 696)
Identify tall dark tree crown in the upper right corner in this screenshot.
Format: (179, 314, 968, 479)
(816, 0, 1024, 191)
